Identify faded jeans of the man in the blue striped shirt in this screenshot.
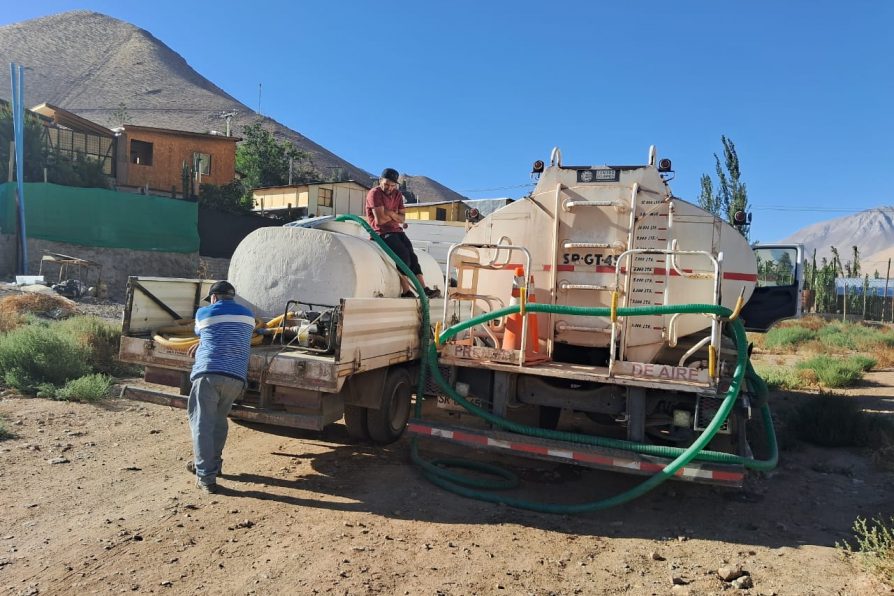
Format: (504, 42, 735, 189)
(186, 374, 245, 484)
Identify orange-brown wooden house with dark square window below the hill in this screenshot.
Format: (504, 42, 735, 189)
(115, 124, 240, 196)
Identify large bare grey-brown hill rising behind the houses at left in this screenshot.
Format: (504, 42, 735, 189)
(0, 10, 455, 200)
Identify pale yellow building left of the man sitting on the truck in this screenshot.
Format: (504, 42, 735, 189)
(252, 180, 370, 217)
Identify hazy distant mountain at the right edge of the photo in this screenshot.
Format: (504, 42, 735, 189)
(781, 206, 894, 274)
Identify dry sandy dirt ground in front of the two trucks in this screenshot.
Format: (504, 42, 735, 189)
(0, 372, 894, 595)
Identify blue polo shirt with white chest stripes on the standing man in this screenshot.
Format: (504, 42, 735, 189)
(189, 300, 255, 381)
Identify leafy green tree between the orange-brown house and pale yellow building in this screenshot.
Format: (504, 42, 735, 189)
(236, 120, 323, 197)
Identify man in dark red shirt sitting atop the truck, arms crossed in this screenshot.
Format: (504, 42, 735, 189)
(366, 168, 441, 298)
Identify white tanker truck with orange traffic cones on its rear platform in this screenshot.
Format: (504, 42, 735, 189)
(410, 147, 803, 484)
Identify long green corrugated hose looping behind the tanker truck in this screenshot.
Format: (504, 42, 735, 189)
(336, 215, 778, 513)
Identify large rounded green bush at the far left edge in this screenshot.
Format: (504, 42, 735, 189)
(0, 324, 90, 394)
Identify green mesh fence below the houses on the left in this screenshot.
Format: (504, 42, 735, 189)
(0, 182, 199, 252)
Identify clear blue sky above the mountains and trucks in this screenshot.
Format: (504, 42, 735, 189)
(0, 0, 894, 242)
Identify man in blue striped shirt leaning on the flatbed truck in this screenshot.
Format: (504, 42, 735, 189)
(186, 281, 255, 493)
